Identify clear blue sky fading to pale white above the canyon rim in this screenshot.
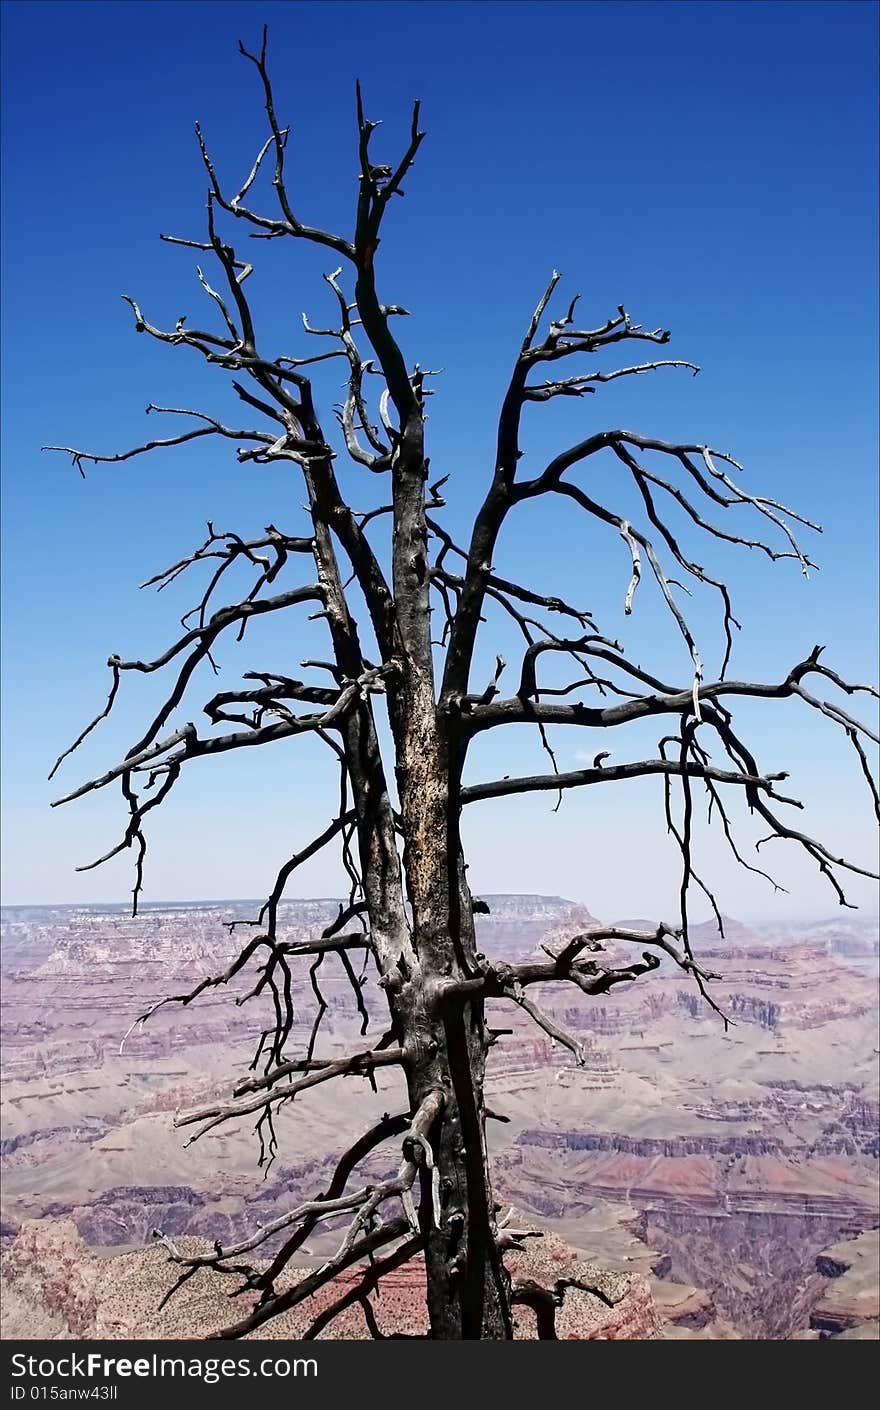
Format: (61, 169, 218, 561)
(3, 0, 877, 918)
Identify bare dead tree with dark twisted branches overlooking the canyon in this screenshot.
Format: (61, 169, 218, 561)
(49, 34, 880, 1340)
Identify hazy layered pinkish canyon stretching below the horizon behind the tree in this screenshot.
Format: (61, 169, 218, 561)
(0, 895, 880, 1340)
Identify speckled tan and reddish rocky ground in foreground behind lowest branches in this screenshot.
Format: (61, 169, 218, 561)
(0, 1220, 880, 1341)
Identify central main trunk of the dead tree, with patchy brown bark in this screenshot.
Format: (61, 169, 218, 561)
(388, 399, 512, 1341)
